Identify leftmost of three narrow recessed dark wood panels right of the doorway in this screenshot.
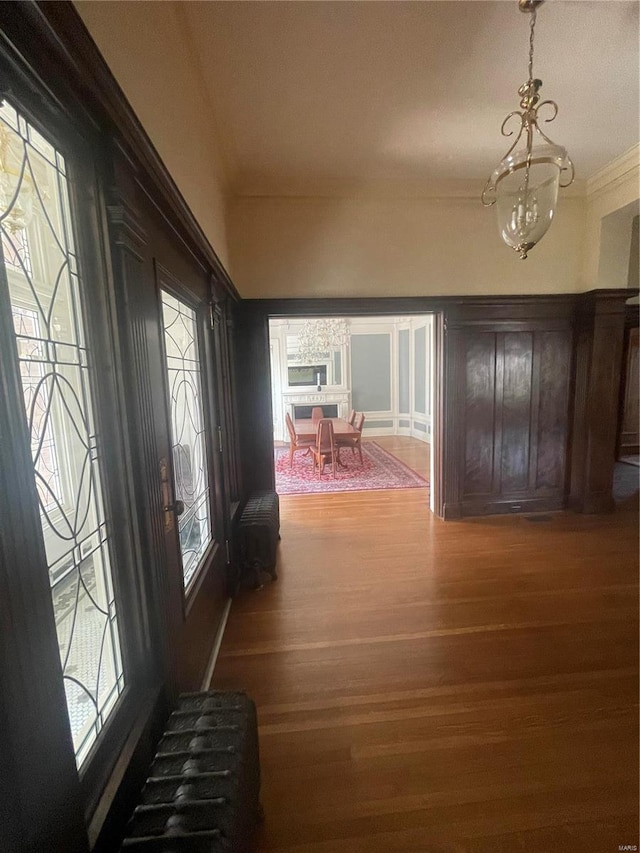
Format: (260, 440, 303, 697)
(463, 332, 496, 495)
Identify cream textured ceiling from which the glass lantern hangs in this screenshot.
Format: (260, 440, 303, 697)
(76, 0, 640, 196)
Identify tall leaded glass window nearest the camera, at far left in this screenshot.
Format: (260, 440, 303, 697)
(0, 101, 124, 766)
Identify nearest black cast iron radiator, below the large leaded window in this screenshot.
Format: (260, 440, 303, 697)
(121, 691, 261, 853)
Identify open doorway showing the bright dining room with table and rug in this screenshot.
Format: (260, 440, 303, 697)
(269, 313, 438, 510)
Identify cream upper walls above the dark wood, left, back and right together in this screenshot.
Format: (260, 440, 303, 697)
(75, 0, 640, 298)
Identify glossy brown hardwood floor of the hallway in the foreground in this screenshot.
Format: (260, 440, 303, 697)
(213, 439, 639, 853)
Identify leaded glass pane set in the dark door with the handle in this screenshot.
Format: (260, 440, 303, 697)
(162, 290, 213, 586)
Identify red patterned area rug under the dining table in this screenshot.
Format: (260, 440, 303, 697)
(275, 441, 429, 495)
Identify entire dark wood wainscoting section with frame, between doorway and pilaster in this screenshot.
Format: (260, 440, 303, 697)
(444, 297, 574, 518)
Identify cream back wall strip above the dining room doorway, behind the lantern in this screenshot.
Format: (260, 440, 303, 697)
(228, 197, 586, 298)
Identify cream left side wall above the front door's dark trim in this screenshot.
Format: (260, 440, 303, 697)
(74, 0, 229, 268)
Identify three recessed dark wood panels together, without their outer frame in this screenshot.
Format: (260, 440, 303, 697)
(462, 330, 560, 509)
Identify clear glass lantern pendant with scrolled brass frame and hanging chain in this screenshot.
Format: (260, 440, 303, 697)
(482, 0, 574, 259)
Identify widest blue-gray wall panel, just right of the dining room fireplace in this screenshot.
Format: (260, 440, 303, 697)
(351, 334, 391, 412)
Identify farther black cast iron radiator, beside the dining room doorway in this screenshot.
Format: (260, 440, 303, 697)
(238, 492, 280, 586)
